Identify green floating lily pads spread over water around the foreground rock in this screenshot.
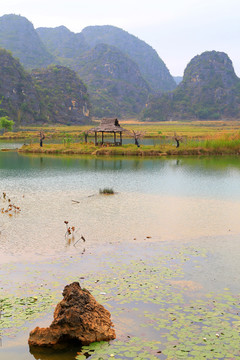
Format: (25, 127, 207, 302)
(0, 245, 240, 360)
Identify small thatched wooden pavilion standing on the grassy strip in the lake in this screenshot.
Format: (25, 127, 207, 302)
(89, 118, 127, 146)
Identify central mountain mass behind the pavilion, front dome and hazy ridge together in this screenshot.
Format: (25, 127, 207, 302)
(37, 26, 176, 117)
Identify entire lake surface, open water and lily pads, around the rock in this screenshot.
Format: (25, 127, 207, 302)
(0, 152, 240, 360)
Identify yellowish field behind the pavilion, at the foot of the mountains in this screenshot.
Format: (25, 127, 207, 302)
(0, 120, 240, 140)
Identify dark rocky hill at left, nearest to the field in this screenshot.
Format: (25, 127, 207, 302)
(0, 49, 90, 125)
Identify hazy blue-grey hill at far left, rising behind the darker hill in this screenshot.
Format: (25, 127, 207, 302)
(0, 15, 55, 69)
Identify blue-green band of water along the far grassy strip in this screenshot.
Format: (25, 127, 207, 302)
(0, 152, 240, 199)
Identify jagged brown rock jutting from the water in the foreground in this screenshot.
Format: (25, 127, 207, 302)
(28, 282, 116, 348)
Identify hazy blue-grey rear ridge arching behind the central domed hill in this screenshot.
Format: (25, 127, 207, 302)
(36, 25, 176, 91)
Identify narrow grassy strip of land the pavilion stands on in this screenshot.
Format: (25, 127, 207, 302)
(19, 132, 240, 156)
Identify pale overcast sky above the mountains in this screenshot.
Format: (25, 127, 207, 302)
(0, 0, 240, 76)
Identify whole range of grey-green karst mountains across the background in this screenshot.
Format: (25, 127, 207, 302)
(0, 15, 240, 123)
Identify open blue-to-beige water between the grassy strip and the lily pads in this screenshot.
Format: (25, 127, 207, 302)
(0, 152, 240, 260)
